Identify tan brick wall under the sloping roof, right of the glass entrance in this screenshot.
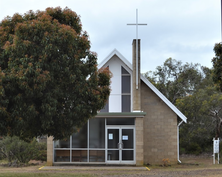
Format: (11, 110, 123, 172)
(141, 82, 177, 164)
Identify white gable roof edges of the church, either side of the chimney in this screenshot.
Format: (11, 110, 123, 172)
(98, 49, 187, 123)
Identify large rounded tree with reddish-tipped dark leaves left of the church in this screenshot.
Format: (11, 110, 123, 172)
(0, 7, 111, 140)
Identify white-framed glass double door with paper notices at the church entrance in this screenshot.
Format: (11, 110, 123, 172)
(106, 126, 135, 164)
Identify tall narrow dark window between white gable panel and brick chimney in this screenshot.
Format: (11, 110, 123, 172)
(121, 67, 131, 112)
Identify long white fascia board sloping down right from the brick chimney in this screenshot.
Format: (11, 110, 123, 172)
(140, 74, 187, 123)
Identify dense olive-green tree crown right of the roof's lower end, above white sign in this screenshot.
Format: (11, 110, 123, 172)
(176, 87, 222, 141)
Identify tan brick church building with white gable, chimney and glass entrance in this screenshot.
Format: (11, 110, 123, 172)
(47, 40, 187, 166)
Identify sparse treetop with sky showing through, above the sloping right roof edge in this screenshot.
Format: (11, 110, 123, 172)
(145, 58, 204, 104)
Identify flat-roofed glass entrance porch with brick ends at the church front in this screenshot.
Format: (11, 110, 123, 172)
(47, 113, 145, 165)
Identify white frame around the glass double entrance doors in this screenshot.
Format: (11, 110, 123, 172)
(105, 125, 136, 164)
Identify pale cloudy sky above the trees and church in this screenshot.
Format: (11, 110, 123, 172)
(0, 0, 221, 73)
